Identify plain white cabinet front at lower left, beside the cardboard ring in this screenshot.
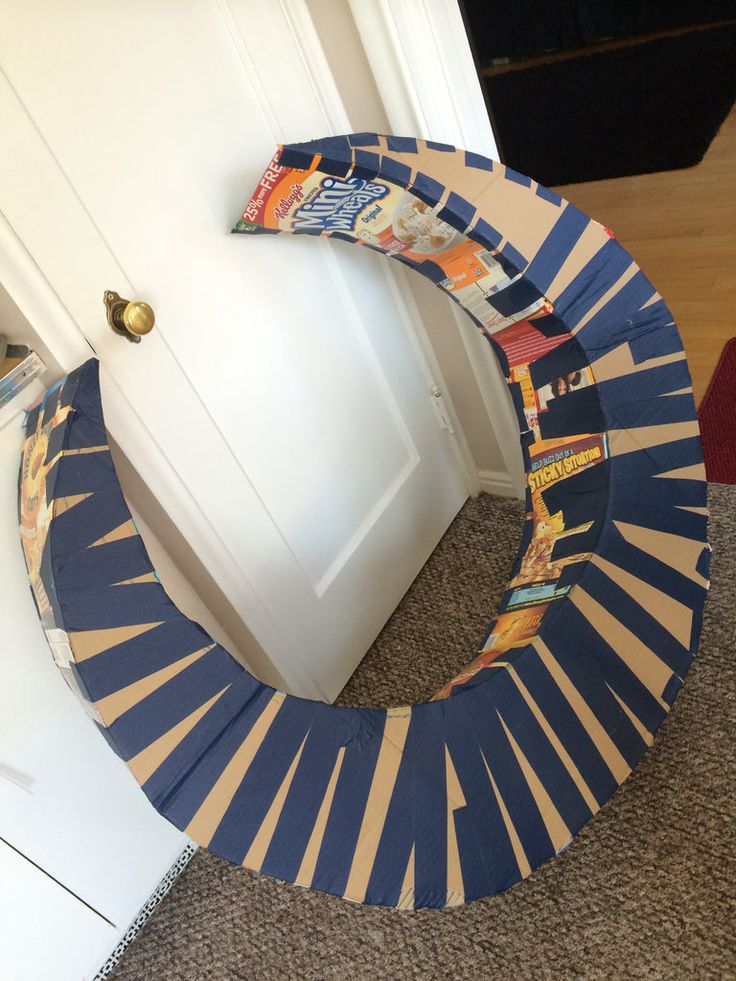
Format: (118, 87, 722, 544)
(0, 398, 187, 981)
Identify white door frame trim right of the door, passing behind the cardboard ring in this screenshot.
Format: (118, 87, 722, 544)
(348, 0, 525, 498)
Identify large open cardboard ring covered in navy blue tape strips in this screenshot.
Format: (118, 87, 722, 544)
(20, 134, 709, 908)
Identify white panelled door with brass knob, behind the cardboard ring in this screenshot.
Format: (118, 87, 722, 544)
(0, 0, 467, 699)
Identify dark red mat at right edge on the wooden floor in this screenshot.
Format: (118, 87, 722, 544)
(698, 337, 736, 484)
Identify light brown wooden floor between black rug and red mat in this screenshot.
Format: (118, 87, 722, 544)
(556, 109, 736, 403)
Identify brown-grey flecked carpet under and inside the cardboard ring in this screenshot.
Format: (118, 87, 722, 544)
(113, 485, 736, 981)
